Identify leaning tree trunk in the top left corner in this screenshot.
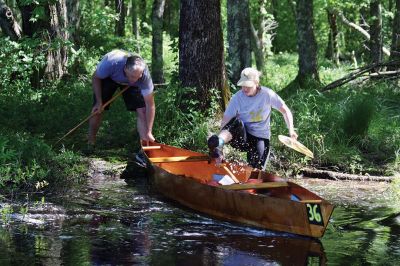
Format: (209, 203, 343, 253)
(0, 0, 21, 41)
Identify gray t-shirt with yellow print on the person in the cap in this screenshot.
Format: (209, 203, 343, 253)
(224, 87, 285, 139)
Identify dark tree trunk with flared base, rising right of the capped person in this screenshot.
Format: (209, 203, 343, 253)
(296, 0, 319, 87)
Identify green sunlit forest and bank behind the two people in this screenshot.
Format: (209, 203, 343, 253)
(0, 0, 400, 196)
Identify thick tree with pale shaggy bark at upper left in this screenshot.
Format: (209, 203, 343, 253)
(17, 0, 68, 83)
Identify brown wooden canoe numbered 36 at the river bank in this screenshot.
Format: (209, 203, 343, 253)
(142, 140, 334, 238)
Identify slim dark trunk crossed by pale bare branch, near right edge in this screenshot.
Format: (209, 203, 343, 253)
(370, 0, 383, 68)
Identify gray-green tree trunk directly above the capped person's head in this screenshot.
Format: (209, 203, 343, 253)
(227, 0, 252, 84)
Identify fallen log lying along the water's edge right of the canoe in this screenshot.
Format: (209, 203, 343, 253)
(300, 168, 395, 182)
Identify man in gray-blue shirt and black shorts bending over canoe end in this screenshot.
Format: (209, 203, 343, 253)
(88, 50, 155, 150)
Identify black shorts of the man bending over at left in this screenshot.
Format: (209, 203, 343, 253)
(93, 78, 146, 111)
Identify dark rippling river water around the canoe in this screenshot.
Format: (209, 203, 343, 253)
(0, 161, 400, 266)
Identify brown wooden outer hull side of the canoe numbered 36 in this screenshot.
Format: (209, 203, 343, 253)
(141, 142, 333, 238)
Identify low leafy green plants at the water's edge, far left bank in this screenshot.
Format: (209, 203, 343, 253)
(0, 133, 83, 192)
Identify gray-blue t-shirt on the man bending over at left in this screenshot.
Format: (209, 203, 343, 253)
(96, 50, 154, 96)
